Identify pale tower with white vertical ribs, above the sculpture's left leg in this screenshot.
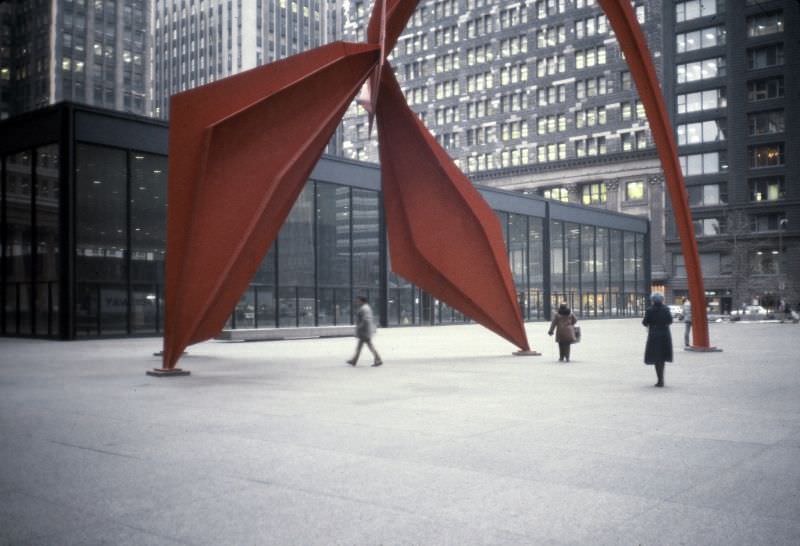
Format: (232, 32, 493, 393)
(153, 0, 342, 118)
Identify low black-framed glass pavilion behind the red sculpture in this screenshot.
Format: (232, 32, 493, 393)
(0, 104, 649, 339)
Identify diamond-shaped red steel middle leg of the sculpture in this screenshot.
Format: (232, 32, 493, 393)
(376, 67, 529, 351)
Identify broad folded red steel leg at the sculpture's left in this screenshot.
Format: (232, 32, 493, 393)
(163, 42, 380, 369)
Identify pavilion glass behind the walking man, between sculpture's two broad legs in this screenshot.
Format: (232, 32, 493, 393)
(234, 181, 382, 329)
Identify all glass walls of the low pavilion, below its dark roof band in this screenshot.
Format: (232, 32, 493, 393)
(0, 143, 646, 337)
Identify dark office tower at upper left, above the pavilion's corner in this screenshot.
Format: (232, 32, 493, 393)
(0, 0, 150, 118)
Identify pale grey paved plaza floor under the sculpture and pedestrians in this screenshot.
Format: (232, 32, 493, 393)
(0, 319, 800, 546)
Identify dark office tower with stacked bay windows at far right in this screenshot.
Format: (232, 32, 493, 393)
(664, 0, 800, 312)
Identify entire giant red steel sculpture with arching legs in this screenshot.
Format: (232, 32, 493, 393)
(156, 0, 708, 373)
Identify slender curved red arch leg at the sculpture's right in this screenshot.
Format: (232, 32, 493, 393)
(598, 0, 710, 349)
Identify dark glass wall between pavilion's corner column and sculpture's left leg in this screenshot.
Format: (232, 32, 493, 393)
(75, 143, 167, 337)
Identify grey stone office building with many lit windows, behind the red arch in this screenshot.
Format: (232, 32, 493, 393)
(344, 0, 668, 285)
